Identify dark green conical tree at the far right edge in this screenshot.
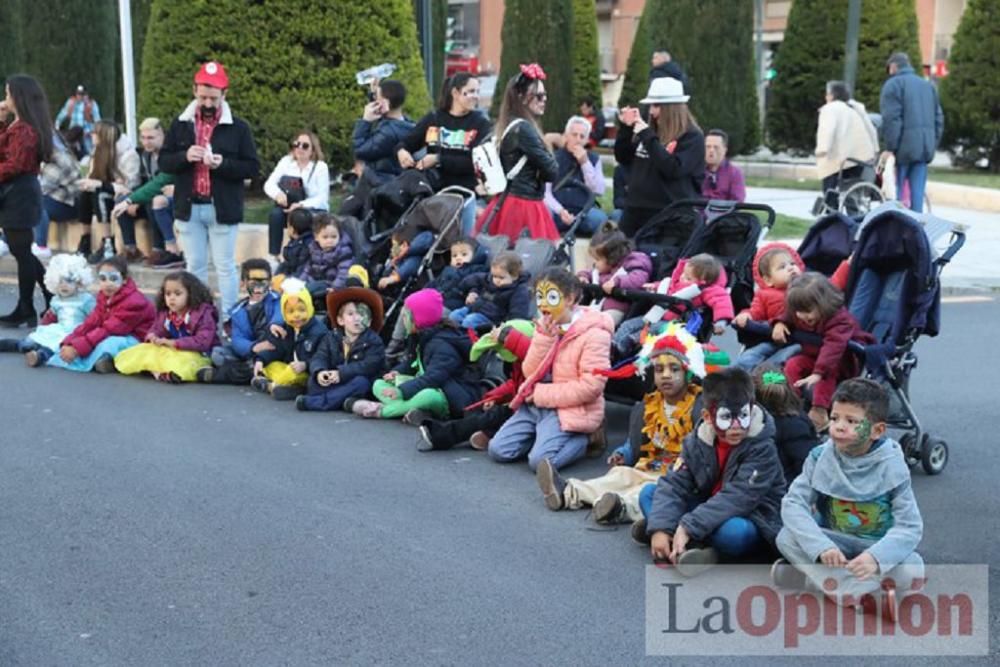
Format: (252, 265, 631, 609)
(941, 0, 1000, 172)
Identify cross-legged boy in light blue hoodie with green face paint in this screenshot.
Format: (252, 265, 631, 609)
(771, 379, 924, 618)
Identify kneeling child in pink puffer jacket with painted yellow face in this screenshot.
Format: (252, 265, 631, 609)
(488, 268, 614, 470)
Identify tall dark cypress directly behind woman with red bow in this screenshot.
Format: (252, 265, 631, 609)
(492, 0, 576, 132)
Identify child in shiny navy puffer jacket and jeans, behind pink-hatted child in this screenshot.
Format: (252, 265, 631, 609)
(451, 251, 533, 329)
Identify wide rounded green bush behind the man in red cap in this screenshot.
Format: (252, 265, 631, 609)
(139, 0, 431, 175)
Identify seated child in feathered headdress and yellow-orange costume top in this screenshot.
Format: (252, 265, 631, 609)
(537, 322, 705, 524)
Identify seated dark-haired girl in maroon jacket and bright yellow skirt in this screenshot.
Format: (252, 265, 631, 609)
(115, 271, 219, 384)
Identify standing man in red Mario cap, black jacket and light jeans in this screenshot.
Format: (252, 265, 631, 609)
(160, 62, 260, 321)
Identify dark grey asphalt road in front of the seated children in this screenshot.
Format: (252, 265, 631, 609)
(0, 287, 1000, 667)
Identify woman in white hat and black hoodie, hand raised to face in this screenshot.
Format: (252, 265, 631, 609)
(615, 78, 705, 237)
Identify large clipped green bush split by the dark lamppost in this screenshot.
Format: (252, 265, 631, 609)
(767, 0, 920, 152)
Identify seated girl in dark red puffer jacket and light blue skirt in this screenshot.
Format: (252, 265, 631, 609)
(35, 257, 156, 373)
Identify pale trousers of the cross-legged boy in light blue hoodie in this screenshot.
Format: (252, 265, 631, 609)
(777, 528, 924, 598)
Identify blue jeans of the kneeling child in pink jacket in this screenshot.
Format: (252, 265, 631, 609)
(489, 405, 588, 470)
